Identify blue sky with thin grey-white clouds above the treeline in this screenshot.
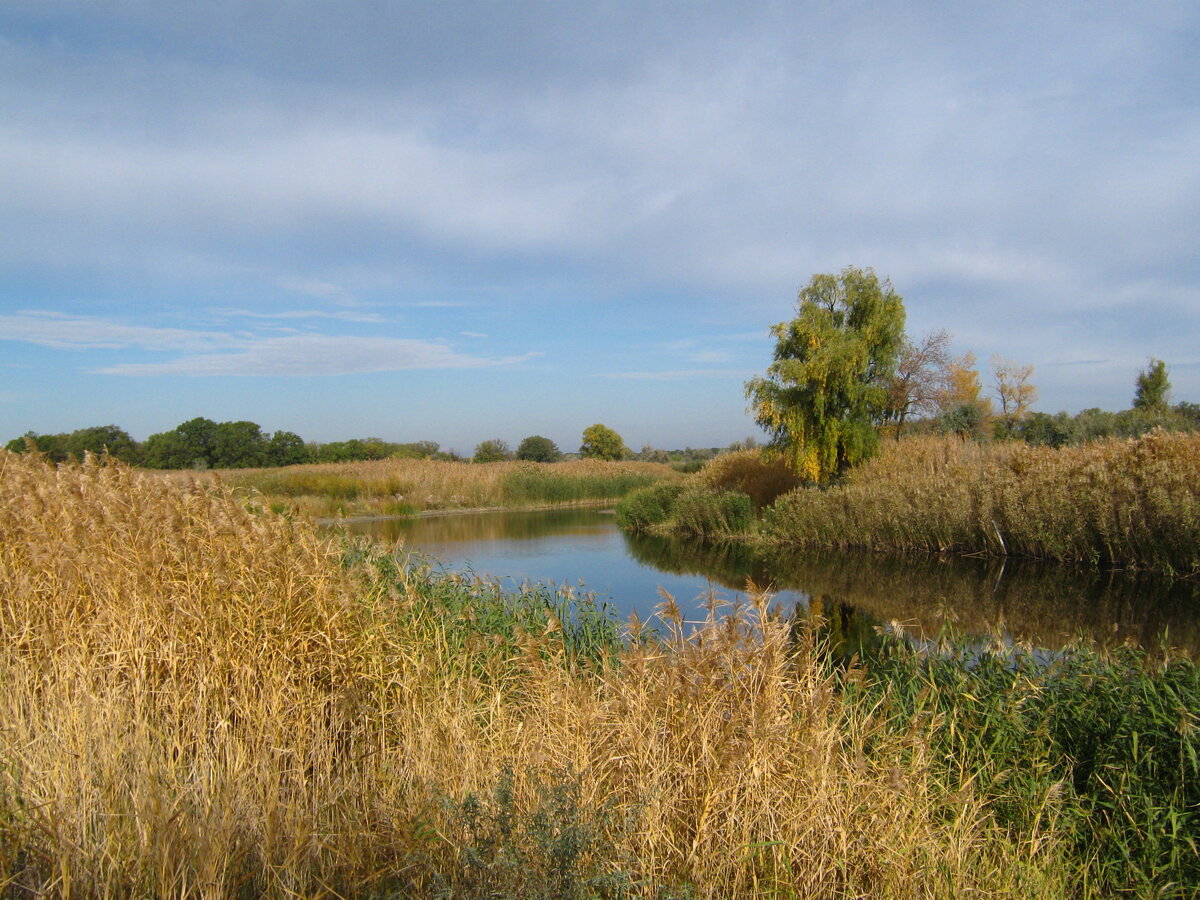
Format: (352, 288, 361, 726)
(0, 0, 1200, 454)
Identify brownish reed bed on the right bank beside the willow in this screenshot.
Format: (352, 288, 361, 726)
(762, 431, 1200, 576)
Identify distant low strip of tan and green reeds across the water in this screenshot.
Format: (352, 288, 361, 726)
(218, 460, 678, 517)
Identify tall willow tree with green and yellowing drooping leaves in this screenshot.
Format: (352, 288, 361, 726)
(746, 266, 905, 481)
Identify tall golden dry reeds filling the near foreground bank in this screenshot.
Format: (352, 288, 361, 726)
(0, 454, 1060, 898)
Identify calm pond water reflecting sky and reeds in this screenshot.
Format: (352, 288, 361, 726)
(343, 509, 1200, 655)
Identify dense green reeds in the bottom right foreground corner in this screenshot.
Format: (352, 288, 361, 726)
(845, 640, 1200, 896)
